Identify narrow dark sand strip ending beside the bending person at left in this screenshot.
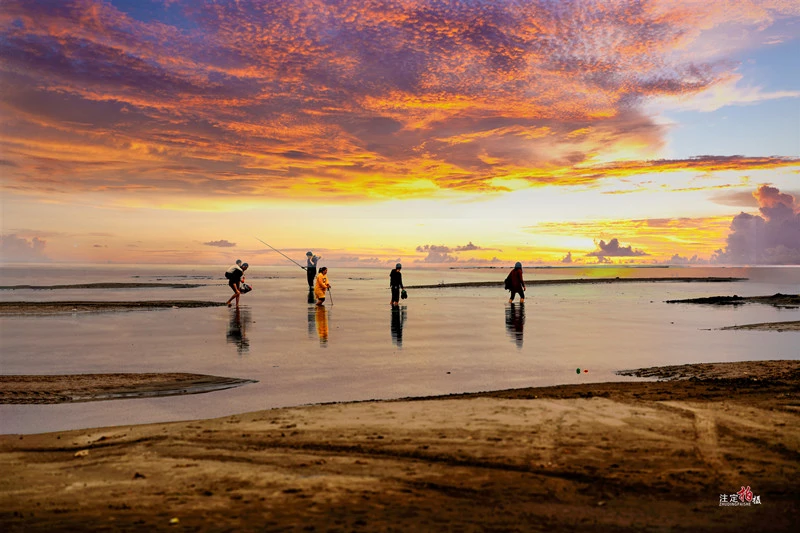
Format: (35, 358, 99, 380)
(0, 300, 225, 316)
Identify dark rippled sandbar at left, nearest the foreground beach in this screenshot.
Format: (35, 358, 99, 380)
(0, 373, 256, 404)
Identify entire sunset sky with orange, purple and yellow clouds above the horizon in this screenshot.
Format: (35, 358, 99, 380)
(0, 0, 800, 266)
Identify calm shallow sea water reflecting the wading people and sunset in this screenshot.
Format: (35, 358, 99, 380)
(0, 265, 800, 433)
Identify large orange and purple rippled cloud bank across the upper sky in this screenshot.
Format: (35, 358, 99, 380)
(0, 0, 798, 200)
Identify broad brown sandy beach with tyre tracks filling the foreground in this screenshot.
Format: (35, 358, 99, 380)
(0, 361, 800, 532)
